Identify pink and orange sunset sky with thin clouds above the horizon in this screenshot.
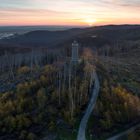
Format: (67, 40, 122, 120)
(0, 0, 140, 26)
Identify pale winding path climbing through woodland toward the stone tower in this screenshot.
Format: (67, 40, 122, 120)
(77, 72, 100, 140)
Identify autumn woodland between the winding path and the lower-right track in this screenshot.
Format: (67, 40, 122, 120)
(88, 64, 140, 139)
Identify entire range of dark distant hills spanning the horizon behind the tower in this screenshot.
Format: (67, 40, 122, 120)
(1, 25, 140, 47)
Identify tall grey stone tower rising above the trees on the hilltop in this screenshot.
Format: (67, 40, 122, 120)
(71, 41, 79, 63)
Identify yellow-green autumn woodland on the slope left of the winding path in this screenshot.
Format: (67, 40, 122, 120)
(0, 56, 92, 140)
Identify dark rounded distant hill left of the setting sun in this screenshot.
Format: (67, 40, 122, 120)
(1, 28, 84, 47)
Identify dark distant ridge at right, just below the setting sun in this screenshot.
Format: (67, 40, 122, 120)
(78, 25, 140, 41)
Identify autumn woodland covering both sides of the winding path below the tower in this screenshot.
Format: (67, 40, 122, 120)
(0, 45, 140, 140)
